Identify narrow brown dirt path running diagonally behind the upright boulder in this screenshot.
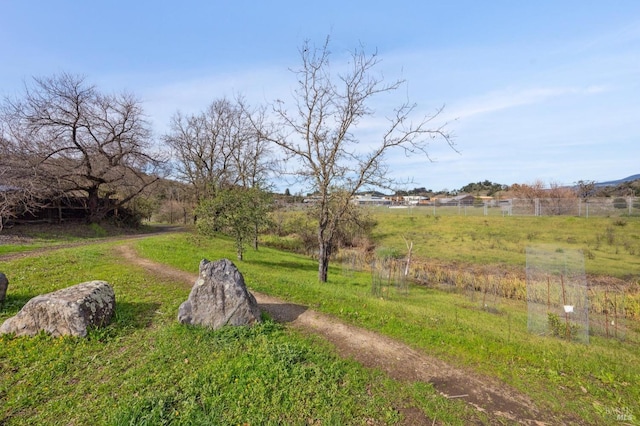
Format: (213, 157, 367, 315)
(117, 244, 564, 425)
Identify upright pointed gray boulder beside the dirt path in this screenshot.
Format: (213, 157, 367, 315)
(178, 259, 260, 329)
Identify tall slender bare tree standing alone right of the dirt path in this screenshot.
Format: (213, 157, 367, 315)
(263, 38, 453, 282)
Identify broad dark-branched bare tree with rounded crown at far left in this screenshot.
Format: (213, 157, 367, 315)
(2, 74, 163, 222)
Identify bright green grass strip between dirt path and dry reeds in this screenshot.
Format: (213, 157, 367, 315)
(137, 234, 640, 423)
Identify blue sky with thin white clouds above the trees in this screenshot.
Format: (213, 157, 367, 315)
(0, 0, 640, 190)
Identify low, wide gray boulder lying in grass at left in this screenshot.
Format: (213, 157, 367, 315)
(0, 281, 116, 337)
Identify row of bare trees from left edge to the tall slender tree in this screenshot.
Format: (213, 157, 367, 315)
(0, 38, 455, 282)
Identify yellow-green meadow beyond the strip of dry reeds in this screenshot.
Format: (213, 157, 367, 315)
(373, 208, 640, 280)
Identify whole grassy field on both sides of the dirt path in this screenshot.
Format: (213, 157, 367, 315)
(0, 213, 640, 425)
